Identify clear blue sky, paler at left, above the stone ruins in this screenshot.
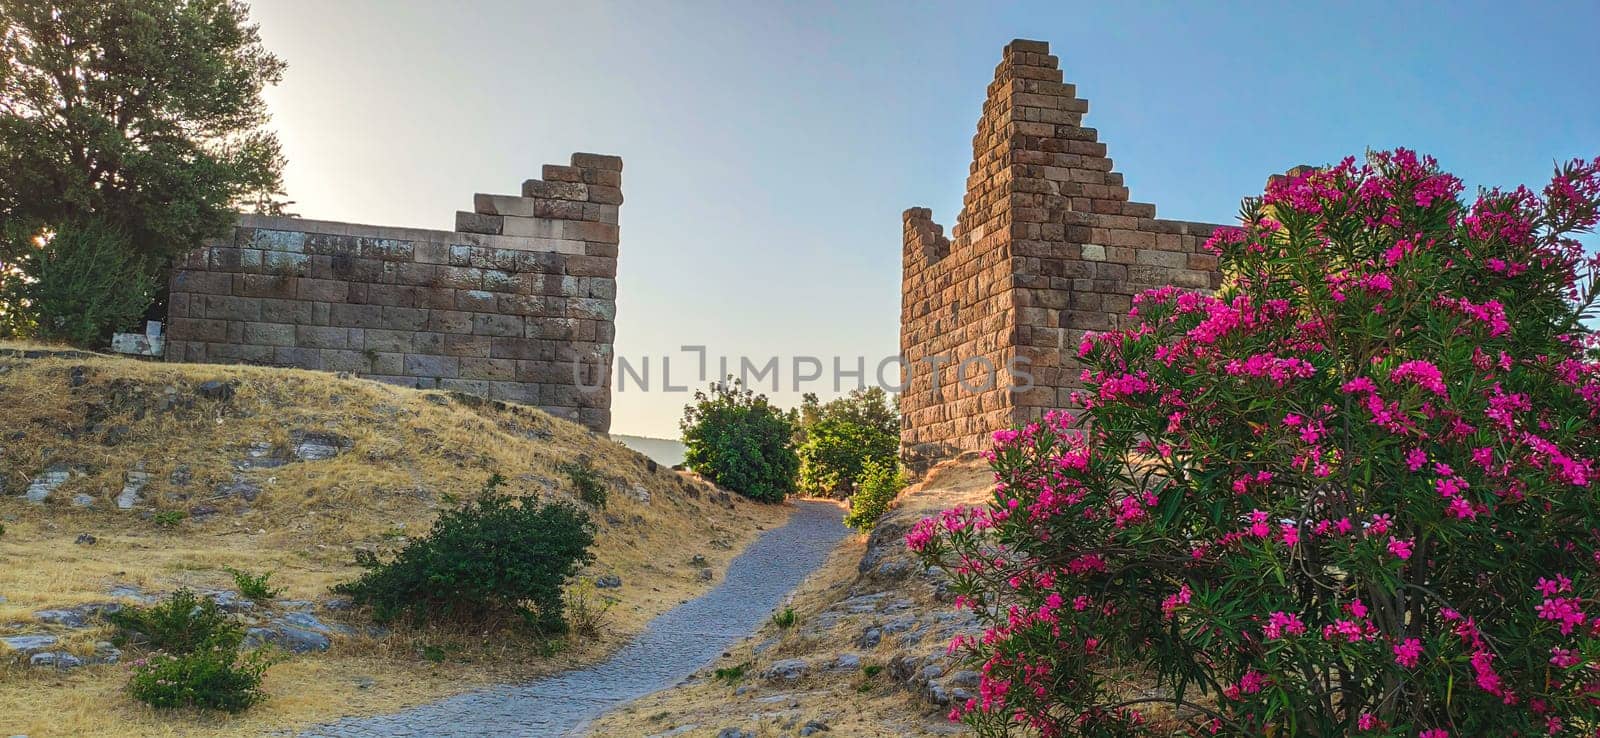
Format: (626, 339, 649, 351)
(253, 0, 1600, 437)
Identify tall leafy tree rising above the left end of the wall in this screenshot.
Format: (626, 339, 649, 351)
(0, 0, 283, 340)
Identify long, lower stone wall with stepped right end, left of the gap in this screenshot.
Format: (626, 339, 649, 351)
(166, 154, 622, 432)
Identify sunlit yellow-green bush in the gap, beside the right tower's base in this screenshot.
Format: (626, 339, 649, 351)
(797, 387, 899, 498)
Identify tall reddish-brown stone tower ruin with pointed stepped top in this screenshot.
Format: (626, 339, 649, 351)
(901, 40, 1221, 467)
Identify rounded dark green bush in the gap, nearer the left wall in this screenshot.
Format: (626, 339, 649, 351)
(680, 376, 800, 503)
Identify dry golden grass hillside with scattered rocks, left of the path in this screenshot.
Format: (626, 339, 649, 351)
(0, 344, 787, 738)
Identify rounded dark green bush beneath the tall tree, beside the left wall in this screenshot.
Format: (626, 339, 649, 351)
(0, 221, 155, 347)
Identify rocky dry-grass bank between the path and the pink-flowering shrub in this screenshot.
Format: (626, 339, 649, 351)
(590, 458, 994, 738)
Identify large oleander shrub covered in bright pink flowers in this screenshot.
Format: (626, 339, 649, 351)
(907, 150, 1600, 738)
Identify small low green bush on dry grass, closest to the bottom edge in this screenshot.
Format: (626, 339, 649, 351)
(128, 645, 272, 712)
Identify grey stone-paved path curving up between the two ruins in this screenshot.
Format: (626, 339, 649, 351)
(298, 501, 846, 738)
